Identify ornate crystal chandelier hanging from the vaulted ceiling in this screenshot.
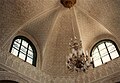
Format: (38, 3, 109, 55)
(66, 7, 90, 72)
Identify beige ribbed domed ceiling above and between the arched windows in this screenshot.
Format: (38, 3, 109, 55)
(0, 0, 120, 76)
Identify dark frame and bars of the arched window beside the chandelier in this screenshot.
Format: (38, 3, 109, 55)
(90, 39, 120, 68)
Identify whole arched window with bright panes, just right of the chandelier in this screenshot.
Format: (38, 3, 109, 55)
(91, 40, 120, 67)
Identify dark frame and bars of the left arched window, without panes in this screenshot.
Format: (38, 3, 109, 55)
(9, 35, 37, 67)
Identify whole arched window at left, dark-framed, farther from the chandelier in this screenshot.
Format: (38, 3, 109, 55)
(10, 36, 37, 66)
